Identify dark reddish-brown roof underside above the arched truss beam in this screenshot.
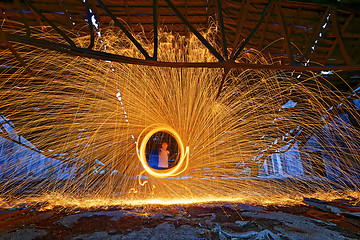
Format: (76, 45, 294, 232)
(0, 0, 360, 71)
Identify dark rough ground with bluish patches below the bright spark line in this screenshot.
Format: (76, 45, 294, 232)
(0, 199, 360, 240)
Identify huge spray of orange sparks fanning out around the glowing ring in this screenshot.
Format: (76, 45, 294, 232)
(0, 25, 360, 207)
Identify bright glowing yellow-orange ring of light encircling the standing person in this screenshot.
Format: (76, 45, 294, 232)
(136, 125, 189, 178)
